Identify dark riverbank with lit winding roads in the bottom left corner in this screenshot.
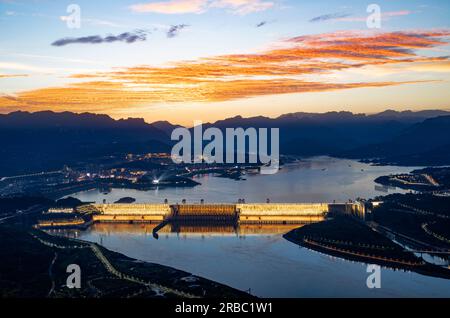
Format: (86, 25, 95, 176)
(0, 226, 250, 299)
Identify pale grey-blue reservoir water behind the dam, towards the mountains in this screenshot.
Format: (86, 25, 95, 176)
(72, 157, 415, 203)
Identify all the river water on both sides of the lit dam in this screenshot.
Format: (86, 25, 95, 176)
(65, 157, 450, 297)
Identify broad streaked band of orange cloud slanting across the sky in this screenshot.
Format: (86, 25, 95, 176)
(0, 31, 450, 113)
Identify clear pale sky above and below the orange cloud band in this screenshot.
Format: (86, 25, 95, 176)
(0, 0, 450, 121)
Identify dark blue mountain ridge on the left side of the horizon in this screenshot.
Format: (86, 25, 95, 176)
(0, 111, 170, 176)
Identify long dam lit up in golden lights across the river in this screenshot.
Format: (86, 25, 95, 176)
(75, 202, 365, 224)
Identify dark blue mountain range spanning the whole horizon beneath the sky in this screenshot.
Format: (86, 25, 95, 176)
(0, 110, 450, 176)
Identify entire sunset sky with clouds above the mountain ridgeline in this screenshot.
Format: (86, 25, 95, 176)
(0, 0, 450, 125)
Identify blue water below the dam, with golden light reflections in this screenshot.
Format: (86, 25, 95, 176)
(59, 224, 450, 297)
